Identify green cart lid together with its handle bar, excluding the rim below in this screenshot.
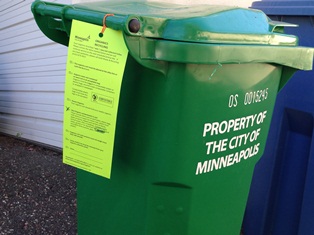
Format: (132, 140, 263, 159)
(32, 1, 298, 46)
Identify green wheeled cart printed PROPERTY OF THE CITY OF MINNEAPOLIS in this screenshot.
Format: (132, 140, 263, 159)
(32, 1, 313, 235)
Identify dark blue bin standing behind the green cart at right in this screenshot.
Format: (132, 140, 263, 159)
(243, 0, 314, 235)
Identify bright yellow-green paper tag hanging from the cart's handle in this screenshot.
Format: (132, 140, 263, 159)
(63, 20, 128, 178)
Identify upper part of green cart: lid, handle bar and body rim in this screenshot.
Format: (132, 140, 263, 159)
(32, 0, 314, 77)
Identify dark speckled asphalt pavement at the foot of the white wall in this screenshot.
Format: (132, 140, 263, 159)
(0, 134, 77, 235)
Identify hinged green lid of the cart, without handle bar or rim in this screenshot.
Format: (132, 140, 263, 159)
(75, 1, 297, 45)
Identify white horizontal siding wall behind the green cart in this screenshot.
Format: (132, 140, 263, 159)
(0, 0, 70, 147)
